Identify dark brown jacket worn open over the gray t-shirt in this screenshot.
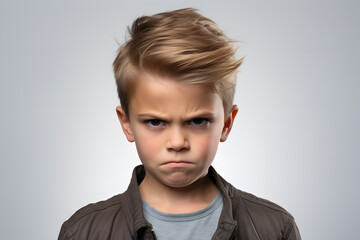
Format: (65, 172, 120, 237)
(58, 165, 301, 240)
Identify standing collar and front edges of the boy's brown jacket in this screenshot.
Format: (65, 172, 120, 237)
(122, 165, 237, 239)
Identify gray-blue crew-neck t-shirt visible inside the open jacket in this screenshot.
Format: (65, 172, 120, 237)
(143, 192, 223, 240)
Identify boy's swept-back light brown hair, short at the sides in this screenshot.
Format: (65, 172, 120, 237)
(113, 8, 243, 117)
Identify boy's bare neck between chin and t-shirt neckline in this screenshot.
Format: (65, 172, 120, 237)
(139, 171, 219, 213)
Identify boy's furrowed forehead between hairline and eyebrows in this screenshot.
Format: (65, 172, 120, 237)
(129, 75, 223, 115)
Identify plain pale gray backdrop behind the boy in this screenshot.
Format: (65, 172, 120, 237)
(0, 0, 360, 240)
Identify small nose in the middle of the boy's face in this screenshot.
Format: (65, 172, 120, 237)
(166, 127, 190, 152)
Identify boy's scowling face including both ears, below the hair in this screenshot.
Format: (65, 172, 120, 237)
(117, 75, 237, 187)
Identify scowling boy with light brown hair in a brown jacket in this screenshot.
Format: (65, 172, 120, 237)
(59, 9, 301, 240)
